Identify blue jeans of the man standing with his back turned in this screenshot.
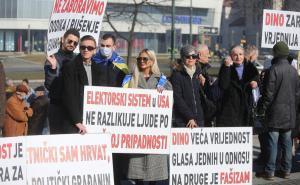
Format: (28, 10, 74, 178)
(265, 129, 292, 175)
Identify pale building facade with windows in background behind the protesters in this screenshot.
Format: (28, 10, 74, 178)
(0, 0, 223, 53)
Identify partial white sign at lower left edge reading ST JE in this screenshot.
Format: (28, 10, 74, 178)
(0, 137, 26, 185)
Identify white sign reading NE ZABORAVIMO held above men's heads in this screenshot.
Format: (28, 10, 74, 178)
(47, 0, 107, 55)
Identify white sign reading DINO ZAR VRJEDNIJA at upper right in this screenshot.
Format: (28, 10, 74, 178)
(261, 9, 300, 50)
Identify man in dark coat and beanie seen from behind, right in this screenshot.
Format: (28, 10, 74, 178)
(257, 42, 300, 180)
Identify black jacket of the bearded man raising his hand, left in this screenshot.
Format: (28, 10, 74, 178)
(44, 49, 76, 105)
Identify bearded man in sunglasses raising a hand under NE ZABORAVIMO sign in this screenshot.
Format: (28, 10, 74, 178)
(44, 29, 80, 134)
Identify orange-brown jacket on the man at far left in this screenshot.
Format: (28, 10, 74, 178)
(3, 94, 33, 137)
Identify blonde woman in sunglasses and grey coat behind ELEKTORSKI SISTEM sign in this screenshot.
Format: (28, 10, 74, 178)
(123, 49, 172, 185)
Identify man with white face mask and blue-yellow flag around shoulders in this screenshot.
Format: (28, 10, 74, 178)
(92, 34, 128, 87)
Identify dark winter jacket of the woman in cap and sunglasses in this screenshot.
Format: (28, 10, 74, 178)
(171, 66, 204, 127)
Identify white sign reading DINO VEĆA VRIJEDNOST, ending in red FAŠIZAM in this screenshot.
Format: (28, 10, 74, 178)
(169, 127, 252, 185)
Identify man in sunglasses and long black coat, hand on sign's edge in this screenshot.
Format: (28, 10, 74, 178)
(62, 35, 98, 134)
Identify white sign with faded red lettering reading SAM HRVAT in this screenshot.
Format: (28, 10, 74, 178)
(24, 134, 114, 185)
